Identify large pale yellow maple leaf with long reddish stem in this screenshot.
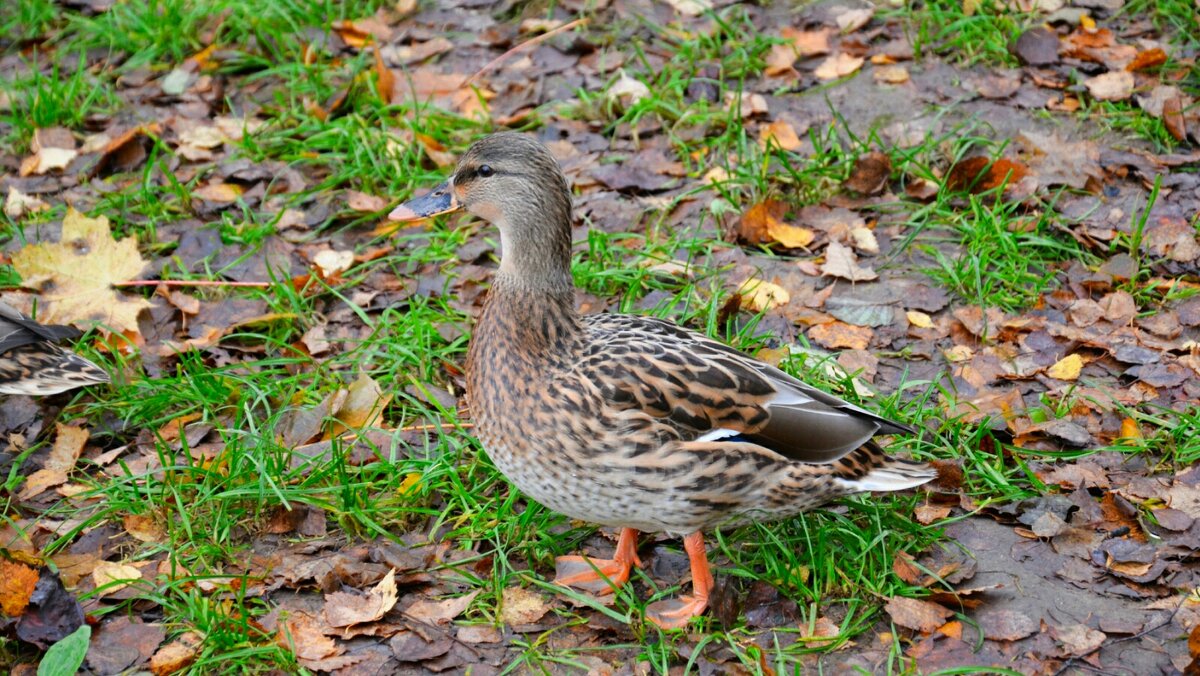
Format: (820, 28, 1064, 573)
(12, 208, 150, 335)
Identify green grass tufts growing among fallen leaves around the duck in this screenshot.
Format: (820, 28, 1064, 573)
(0, 0, 1200, 672)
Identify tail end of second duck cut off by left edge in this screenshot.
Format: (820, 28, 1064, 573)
(0, 301, 109, 396)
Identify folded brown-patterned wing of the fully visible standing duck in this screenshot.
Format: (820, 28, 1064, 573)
(580, 315, 913, 462)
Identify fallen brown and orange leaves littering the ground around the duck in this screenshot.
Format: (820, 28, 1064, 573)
(0, 2, 1200, 674)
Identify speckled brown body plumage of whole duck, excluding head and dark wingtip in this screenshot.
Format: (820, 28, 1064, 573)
(468, 279, 932, 534)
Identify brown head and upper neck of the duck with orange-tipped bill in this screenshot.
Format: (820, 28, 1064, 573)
(388, 133, 571, 286)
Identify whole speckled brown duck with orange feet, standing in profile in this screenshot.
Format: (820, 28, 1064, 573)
(389, 133, 935, 628)
